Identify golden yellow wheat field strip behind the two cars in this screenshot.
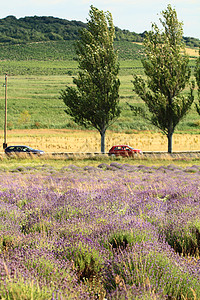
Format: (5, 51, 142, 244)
(0, 129, 200, 153)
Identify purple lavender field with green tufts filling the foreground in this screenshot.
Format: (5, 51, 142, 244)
(0, 162, 200, 300)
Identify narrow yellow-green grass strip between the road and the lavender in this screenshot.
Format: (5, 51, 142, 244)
(0, 155, 200, 172)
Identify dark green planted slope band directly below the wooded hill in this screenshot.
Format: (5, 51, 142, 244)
(0, 40, 143, 67)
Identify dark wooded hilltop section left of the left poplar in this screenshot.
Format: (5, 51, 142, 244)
(0, 16, 86, 44)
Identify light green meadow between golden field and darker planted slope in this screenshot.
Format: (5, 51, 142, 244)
(0, 66, 200, 134)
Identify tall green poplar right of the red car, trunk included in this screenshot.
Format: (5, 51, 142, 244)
(131, 5, 194, 153)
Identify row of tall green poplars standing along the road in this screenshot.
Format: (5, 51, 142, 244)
(61, 5, 200, 153)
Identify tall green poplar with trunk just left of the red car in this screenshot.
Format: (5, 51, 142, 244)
(61, 6, 120, 153)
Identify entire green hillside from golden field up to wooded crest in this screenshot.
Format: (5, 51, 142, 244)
(0, 16, 200, 133)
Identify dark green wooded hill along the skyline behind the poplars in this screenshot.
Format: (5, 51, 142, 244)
(0, 16, 200, 47)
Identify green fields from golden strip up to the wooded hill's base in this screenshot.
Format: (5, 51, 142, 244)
(0, 41, 200, 133)
